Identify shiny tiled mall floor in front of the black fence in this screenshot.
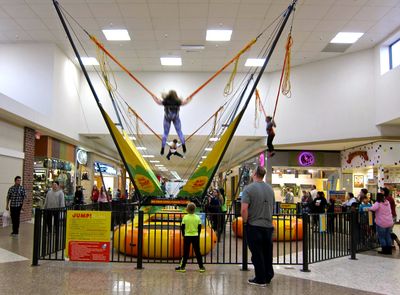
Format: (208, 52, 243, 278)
(0, 223, 400, 295)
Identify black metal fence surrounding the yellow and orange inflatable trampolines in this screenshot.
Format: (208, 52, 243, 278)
(33, 204, 378, 271)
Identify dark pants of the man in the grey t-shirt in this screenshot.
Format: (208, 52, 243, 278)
(246, 224, 274, 284)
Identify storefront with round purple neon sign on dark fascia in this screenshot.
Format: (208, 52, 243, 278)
(227, 151, 340, 202)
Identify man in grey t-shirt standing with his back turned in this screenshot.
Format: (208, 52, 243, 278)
(241, 166, 275, 287)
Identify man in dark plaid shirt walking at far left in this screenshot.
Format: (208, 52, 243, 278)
(6, 176, 26, 237)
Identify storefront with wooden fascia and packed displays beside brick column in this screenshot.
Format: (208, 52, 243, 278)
(33, 136, 76, 208)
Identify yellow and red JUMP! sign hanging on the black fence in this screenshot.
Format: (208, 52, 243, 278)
(65, 210, 111, 262)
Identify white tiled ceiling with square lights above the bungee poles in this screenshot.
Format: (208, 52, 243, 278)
(0, 0, 400, 72)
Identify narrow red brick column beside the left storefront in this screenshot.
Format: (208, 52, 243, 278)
(21, 127, 35, 221)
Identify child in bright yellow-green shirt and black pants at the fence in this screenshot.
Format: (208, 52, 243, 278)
(175, 203, 206, 272)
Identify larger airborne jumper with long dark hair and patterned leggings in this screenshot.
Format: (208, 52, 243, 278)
(153, 90, 192, 155)
